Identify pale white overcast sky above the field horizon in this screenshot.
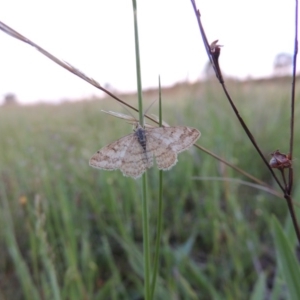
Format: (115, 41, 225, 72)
(0, 0, 295, 103)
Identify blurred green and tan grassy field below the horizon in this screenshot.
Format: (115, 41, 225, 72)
(0, 79, 300, 300)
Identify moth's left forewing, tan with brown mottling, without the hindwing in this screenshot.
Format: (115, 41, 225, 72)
(89, 133, 134, 170)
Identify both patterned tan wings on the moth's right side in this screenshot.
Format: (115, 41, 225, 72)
(146, 126, 201, 170)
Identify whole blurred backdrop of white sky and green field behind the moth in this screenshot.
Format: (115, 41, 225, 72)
(0, 0, 300, 300)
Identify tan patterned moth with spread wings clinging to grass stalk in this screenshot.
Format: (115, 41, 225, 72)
(89, 116, 201, 179)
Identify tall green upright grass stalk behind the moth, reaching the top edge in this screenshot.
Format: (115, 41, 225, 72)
(132, 0, 151, 300)
